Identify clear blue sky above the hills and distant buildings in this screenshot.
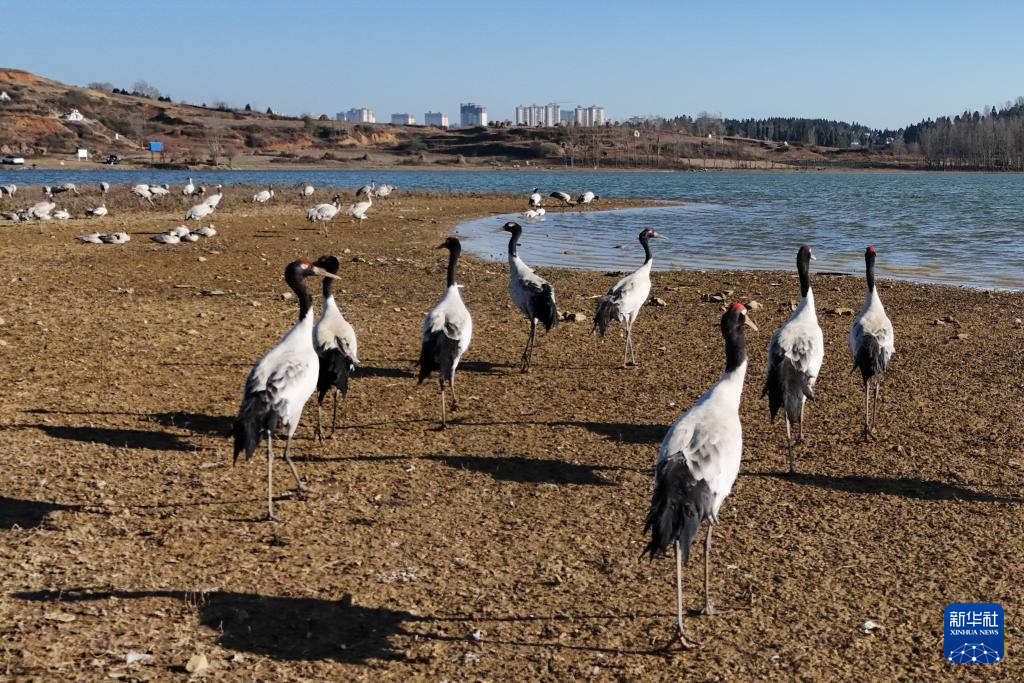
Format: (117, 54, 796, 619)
(0, 0, 1024, 128)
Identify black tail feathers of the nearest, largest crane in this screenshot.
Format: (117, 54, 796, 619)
(640, 458, 714, 562)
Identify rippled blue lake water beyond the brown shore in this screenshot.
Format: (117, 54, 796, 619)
(0, 168, 1024, 290)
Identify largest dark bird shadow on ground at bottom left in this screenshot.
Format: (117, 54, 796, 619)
(12, 590, 419, 664)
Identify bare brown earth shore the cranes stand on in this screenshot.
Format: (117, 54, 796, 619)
(0, 188, 1024, 681)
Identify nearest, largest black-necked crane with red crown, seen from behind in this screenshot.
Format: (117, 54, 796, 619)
(644, 303, 758, 648)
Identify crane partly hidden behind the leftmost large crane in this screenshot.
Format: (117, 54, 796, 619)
(313, 256, 359, 439)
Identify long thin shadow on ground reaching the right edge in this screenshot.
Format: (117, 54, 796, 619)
(741, 472, 1021, 503)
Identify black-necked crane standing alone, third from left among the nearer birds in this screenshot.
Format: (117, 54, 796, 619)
(419, 238, 473, 429)
